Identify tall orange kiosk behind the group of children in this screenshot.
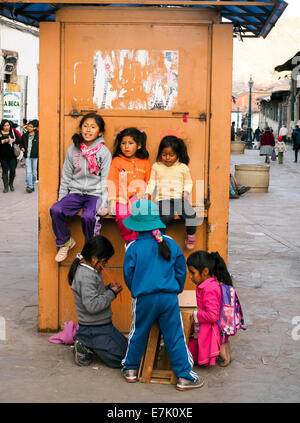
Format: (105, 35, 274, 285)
(38, 6, 233, 332)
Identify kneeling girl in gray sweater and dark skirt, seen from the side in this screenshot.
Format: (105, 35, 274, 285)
(68, 235, 127, 368)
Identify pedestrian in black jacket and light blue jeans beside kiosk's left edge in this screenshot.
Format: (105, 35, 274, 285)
(21, 120, 39, 194)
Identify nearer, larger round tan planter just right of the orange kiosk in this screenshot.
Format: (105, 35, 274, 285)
(235, 165, 270, 192)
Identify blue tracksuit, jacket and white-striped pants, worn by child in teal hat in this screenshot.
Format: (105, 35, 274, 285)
(122, 231, 198, 380)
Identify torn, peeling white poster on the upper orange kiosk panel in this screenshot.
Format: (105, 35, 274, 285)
(93, 50, 179, 110)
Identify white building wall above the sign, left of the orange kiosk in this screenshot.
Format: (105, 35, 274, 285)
(0, 24, 39, 120)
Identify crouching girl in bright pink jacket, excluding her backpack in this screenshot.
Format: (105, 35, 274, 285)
(187, 250, 232, 367)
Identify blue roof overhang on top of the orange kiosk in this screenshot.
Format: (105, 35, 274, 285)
(0, 0, 288, 38)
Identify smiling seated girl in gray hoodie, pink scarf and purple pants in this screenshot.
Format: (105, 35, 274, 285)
(50, 113, 111, 262)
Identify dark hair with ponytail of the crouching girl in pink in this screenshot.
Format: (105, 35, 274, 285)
(187, 250, 233, 286)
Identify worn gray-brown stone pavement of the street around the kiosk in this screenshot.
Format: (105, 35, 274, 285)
(0, 147, 300, 404)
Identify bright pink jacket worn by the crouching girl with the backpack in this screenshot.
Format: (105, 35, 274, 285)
(188, 278, 226, 365)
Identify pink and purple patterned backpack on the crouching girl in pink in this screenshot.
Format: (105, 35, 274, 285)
(217, 283, 246, 340)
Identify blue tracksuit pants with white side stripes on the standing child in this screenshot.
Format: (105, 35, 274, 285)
(122, 292, 198, 380)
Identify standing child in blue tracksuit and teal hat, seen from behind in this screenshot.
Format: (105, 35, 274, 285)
(122, 200, 203, 390)
